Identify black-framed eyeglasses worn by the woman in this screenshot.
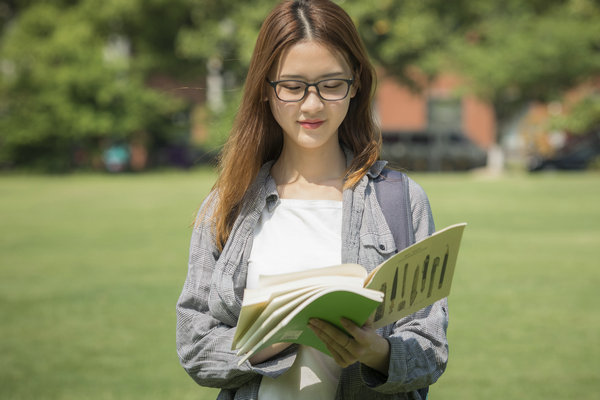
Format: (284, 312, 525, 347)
(267, 78, 354, 103)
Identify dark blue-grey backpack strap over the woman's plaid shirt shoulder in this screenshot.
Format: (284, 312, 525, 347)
(374, 168, 429, 399)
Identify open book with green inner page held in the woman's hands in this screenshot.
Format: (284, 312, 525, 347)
(232, 223, 466, 364)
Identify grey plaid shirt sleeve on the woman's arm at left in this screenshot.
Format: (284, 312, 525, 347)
(176, 198, 295, 390)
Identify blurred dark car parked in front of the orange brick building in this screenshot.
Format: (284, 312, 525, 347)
(381, 131, 487, 171)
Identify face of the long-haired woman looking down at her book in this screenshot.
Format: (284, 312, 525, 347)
(269, 41, 356, 150)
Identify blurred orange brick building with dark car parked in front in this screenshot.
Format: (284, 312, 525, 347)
(375, 73, 496, 171)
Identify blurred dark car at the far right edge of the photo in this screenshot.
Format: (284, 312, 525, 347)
(529, 129, 600, 172)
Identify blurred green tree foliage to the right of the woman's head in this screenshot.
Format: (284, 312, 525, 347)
(347, 0, 600, 148)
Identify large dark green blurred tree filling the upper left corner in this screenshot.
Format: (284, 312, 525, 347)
(0, 0, 197, 170)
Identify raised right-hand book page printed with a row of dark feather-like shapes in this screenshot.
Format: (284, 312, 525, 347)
(366, 223, 466, 328)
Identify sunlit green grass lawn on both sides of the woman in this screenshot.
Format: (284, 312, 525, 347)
(0, 170, 600, 399)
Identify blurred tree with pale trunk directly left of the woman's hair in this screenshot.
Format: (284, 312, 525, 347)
(177, 0, 276, 150)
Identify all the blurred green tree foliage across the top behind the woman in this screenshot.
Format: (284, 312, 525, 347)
(0, 0, 600, 170)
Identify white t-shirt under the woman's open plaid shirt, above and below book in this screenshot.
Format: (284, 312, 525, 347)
(246, 199, 342, 400)
